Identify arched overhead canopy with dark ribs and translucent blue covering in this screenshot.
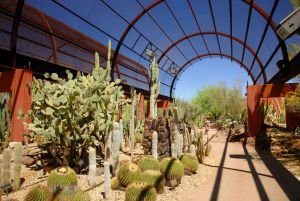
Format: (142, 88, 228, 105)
(0, 0, 300, 97)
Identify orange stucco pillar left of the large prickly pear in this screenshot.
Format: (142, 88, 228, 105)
(0, 69, 32, 142)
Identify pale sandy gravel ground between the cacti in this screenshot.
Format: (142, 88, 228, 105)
(0, 144, 215, 201)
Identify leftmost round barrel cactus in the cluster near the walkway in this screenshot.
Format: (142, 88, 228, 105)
(117, 163, 142, 187)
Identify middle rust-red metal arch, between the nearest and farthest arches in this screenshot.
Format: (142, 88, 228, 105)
(157, 31, 267, 83)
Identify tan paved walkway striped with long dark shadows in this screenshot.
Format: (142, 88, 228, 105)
(187, 131, 300, 201)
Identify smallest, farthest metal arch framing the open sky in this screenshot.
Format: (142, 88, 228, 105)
(170, 52, 256, 97)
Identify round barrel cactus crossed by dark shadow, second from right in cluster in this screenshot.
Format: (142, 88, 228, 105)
(160, 158, 184, 180)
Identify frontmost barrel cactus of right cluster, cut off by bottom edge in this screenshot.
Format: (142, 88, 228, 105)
(125, 181, 157, 201)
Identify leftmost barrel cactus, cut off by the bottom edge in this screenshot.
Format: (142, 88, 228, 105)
(24, 186, 52, 201)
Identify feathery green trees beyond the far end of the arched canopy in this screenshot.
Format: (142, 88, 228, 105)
(192, 83, 246, 121)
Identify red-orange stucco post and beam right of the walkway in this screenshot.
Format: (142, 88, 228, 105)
(247, 84, 300, 136)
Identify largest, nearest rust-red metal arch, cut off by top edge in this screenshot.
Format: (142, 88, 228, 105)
(111, 0, 288, 80)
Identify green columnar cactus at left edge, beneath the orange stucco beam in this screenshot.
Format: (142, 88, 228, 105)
(0, 93, 12, 151)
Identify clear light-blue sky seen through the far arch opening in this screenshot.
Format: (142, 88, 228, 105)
(175, 58, 252, 99)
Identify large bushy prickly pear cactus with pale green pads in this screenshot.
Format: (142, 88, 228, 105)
(23, 43, 126, 171)
